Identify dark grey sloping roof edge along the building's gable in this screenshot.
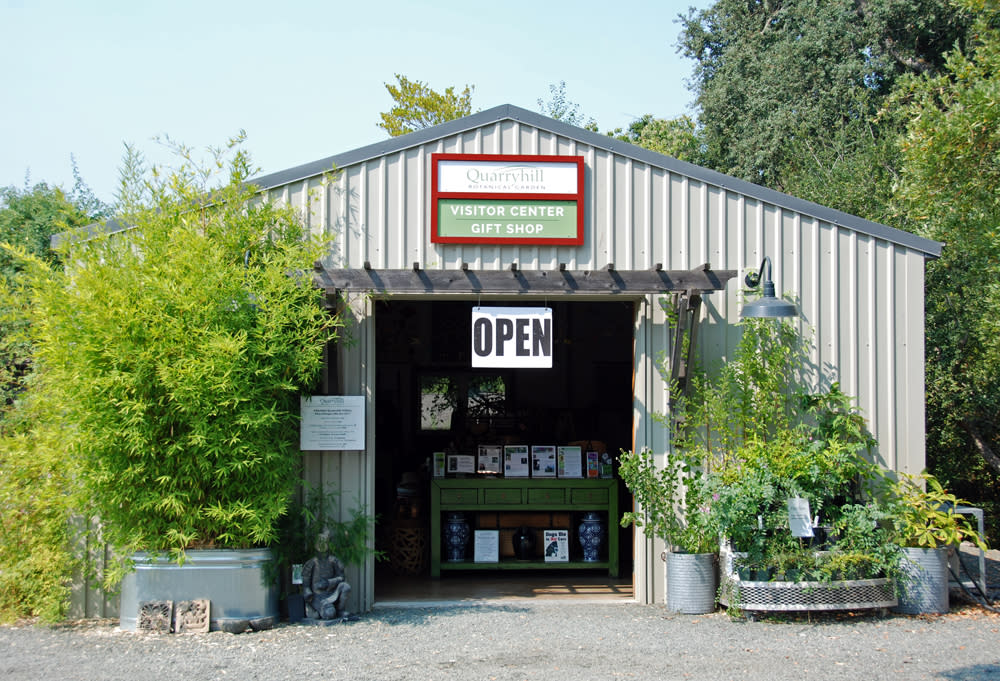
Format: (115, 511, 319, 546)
(251, 104, 943, 257)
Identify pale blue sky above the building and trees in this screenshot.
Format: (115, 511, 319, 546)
(0, 0, 711, 201)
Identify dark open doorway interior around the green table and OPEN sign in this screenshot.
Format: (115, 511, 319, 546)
(374, 300, 635, 603)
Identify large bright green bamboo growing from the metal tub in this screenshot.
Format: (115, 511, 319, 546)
(0, 137, 337, 581)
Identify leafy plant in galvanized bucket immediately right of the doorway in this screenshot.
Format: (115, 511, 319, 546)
(619, 450, 719, 614)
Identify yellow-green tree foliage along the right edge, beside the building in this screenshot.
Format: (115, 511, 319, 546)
(893, 0, 1000, 540)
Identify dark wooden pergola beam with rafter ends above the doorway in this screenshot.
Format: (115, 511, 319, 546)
(314, 263, 736, 296)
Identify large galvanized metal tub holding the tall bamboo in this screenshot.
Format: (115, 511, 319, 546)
(119, 549, 278, 631)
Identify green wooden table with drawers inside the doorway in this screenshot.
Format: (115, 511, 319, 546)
(431, 477, 619, 577)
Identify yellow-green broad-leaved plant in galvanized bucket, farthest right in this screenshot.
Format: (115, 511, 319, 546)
(888, 472, 987, 614)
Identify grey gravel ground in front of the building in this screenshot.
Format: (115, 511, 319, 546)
(0, 600, 1000, 681)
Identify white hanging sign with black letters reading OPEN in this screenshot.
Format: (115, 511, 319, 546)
(472, 307, 552, 369)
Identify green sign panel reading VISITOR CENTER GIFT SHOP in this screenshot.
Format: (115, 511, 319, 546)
(437, 199, 578, 241)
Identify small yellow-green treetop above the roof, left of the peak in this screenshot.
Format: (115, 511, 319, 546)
(378, 73, 474, 137)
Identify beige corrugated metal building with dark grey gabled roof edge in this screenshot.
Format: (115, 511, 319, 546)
(72, 106, 941, 609)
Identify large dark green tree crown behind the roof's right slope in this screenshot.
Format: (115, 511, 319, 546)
(680, 0, 967, 190)
